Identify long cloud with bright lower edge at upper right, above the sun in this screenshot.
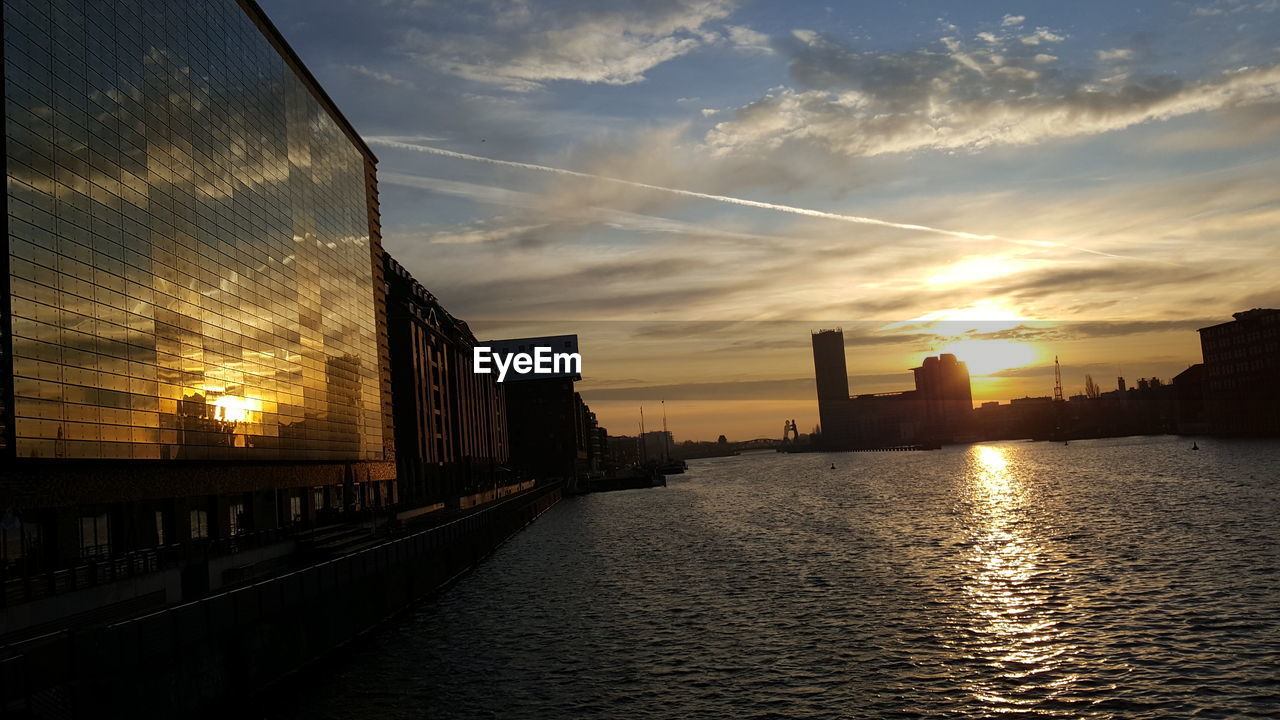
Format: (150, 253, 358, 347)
(704, 28, 1280, 158)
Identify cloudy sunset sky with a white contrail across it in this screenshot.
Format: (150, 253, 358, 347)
(262, 0, 1280, 441)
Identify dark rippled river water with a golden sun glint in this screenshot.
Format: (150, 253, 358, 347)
(270, 438, 1280, 720)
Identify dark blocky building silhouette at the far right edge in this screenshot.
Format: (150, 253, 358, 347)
(1199, 307, 1280, 436)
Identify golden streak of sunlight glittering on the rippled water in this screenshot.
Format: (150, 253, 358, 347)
(959, 445, 1074, 711)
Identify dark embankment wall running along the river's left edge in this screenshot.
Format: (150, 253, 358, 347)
(0, 484, 561, 719)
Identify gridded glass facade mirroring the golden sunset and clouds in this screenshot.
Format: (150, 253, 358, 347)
(0, 0, 392, 461)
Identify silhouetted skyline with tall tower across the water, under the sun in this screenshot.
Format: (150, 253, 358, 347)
(813, 309, 1280, 450)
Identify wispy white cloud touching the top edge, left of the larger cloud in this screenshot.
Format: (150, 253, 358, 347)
(401, 0, 737, 91)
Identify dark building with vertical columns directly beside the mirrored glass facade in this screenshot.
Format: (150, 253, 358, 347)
(384, 255, 509, 514)
